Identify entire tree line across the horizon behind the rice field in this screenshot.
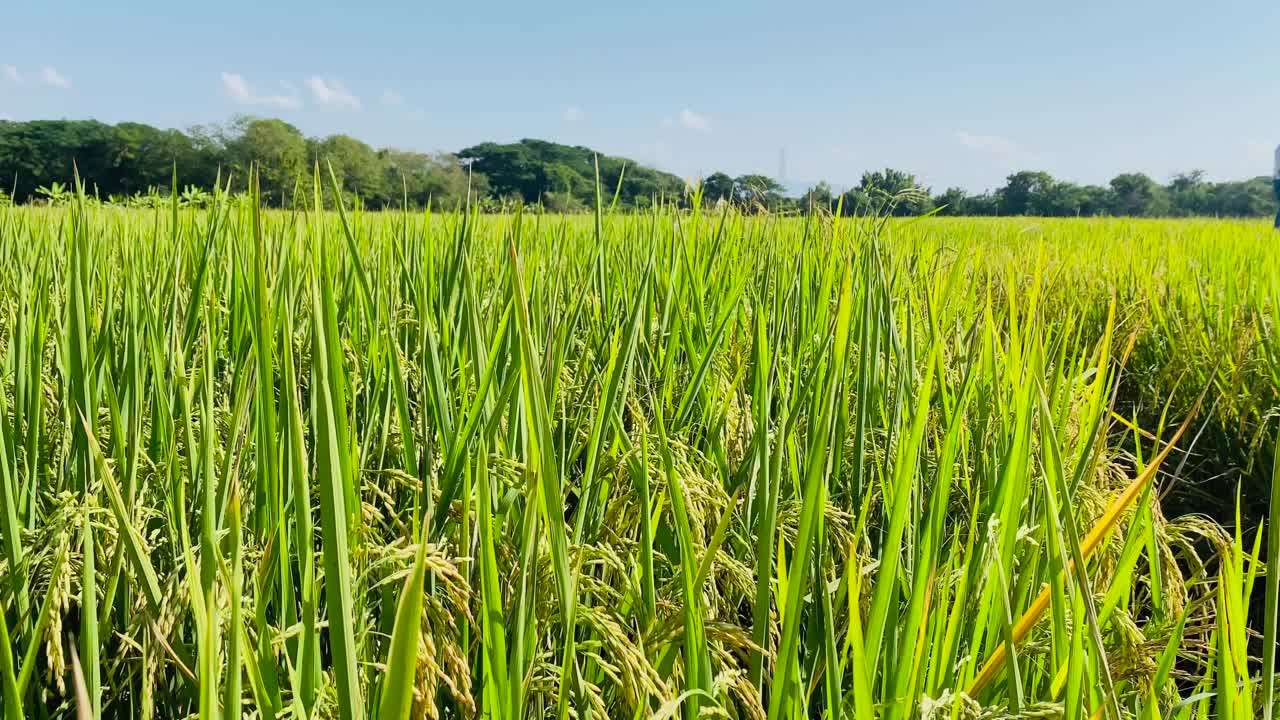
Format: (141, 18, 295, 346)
(0, 117, 1274, 217)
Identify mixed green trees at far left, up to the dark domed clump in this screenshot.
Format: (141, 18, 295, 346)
(0, 118, 478, 208)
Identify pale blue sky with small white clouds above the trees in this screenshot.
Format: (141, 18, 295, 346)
(0, 0, 1280, 190)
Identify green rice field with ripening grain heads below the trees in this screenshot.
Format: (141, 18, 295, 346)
(0, 185, 1280, 720)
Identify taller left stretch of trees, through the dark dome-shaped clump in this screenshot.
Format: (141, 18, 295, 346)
(0, 117, 685, 211)
